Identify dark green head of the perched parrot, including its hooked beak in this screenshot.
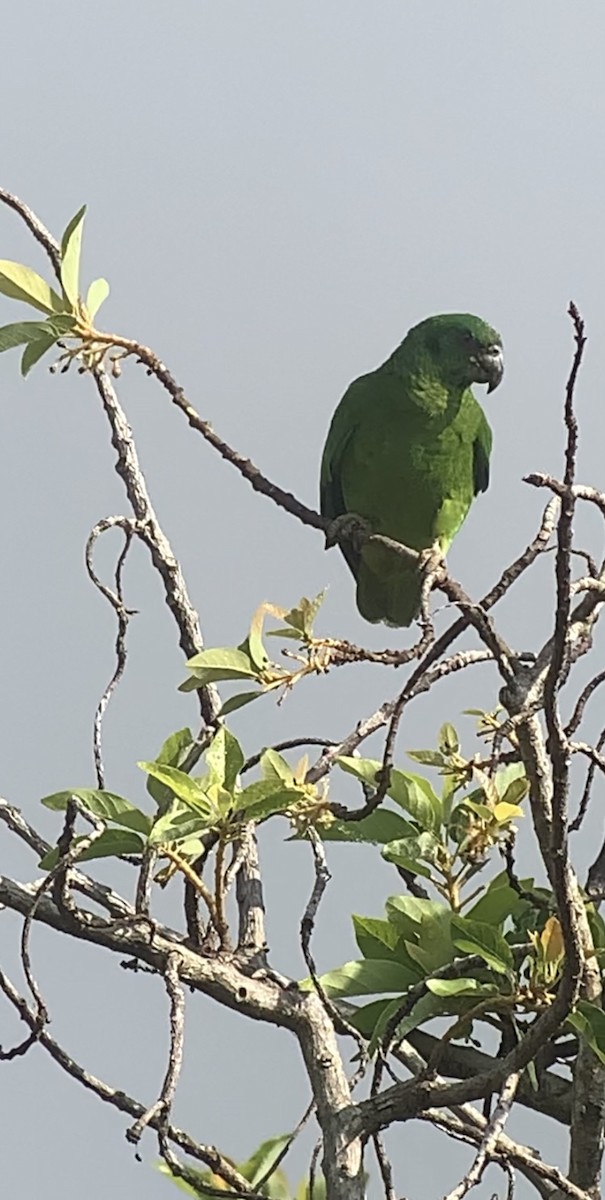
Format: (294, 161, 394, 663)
(402, 312, 504, 391)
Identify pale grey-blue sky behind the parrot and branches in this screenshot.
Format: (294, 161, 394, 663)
(0, 0, 605, 1200)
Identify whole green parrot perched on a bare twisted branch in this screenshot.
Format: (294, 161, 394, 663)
(321, 313, 504, 625)
